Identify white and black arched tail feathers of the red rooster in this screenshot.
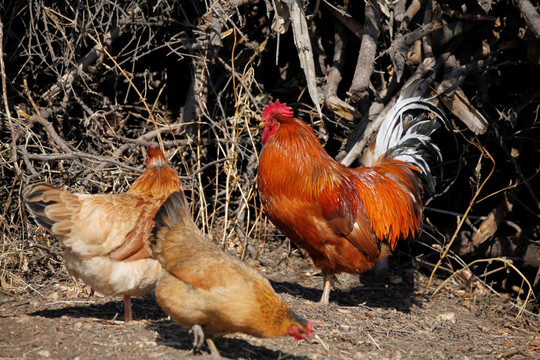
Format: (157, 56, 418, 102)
(363, 97, 447, 191)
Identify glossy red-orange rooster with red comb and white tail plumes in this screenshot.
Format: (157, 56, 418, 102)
(258, 98, 444, 305)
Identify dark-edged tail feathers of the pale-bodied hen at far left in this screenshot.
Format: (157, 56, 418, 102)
(22, 183, 62, 230)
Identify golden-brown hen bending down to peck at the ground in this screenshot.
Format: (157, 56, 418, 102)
(152, 192, 313, 357)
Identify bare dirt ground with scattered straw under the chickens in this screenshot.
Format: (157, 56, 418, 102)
(0, 246, 540, 360)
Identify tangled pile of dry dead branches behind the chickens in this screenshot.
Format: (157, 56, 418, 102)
(0, 0, 540, 312)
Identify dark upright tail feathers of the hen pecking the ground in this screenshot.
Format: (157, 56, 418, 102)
(152, 191, 194, 246)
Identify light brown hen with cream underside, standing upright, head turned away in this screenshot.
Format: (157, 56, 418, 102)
(23, 146, 182, 322)
